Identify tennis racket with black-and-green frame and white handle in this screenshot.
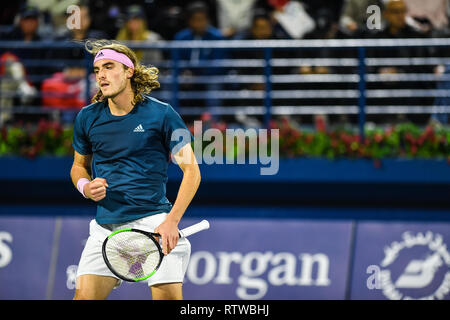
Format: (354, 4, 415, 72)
(102, 220, 209, 282)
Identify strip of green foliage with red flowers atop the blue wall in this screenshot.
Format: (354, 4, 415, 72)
(0, 118, 450, 161)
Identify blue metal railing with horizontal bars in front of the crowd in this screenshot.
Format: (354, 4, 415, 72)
(0, 38, 450, 135)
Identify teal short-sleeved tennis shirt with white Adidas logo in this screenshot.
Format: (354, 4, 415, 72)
(73, 96, 192, 224)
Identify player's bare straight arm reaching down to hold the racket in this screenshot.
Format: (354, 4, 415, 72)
(155, 144, 201, 254)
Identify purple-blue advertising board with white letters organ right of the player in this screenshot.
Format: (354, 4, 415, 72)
(178, 218, 352, 300)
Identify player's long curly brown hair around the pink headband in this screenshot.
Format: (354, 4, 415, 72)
(85, 39, 160, 105)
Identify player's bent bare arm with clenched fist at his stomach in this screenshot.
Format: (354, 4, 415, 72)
(70, 151, 108, 201)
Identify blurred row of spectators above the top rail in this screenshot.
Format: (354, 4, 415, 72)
(0, 0, 450, 41)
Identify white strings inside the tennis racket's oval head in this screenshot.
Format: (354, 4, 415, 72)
(105, 232, 160, 279)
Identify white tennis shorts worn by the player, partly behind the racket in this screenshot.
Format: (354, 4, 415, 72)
(77, 213, 191, 288)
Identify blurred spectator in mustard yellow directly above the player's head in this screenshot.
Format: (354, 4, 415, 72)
(116, 5, 163, 64)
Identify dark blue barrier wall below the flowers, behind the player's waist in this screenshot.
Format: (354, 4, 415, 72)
(0, 157, 450, 207)
